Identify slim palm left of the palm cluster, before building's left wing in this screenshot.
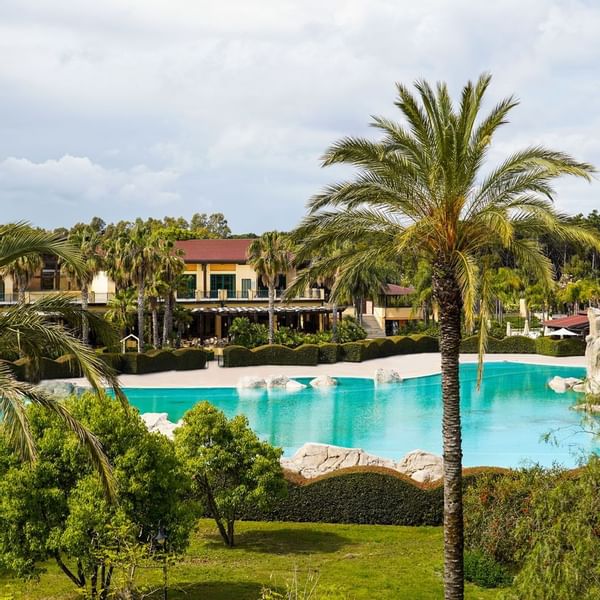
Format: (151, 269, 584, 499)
(64, 225, 102, 344)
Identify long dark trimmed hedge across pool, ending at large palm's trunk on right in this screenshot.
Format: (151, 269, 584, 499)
(223, 335, 438, 367)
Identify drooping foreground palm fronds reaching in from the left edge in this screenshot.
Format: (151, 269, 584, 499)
(0, 223, 127, 498)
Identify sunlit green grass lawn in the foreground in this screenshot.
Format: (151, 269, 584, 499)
(0, 520, 506, 600)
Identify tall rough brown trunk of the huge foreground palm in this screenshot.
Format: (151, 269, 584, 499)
(433, 264, 464, 600)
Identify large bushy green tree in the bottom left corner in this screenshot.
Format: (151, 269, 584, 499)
(0, 393, 194, 600)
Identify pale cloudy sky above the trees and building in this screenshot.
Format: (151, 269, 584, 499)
(0, 0, 600, 233)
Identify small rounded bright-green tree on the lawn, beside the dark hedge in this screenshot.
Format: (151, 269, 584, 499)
(175, 402, 287, 547)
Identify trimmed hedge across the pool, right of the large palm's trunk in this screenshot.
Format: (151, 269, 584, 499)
(460, 335, 585, 356)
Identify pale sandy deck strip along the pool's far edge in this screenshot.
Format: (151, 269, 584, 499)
(68, 352, 585, 388)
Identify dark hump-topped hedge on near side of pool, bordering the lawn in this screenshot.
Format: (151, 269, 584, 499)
(245, 471, 443, 525)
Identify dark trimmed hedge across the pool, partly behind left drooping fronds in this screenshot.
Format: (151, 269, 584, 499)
(9, 348, 209, 381)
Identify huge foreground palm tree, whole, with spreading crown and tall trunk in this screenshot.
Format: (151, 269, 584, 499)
(294, 75, 599, 600)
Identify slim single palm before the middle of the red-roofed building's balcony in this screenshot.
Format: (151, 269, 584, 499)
(248, 231, 291, 344)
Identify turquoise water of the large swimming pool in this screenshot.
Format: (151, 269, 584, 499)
(125, 363, 600, 467)
